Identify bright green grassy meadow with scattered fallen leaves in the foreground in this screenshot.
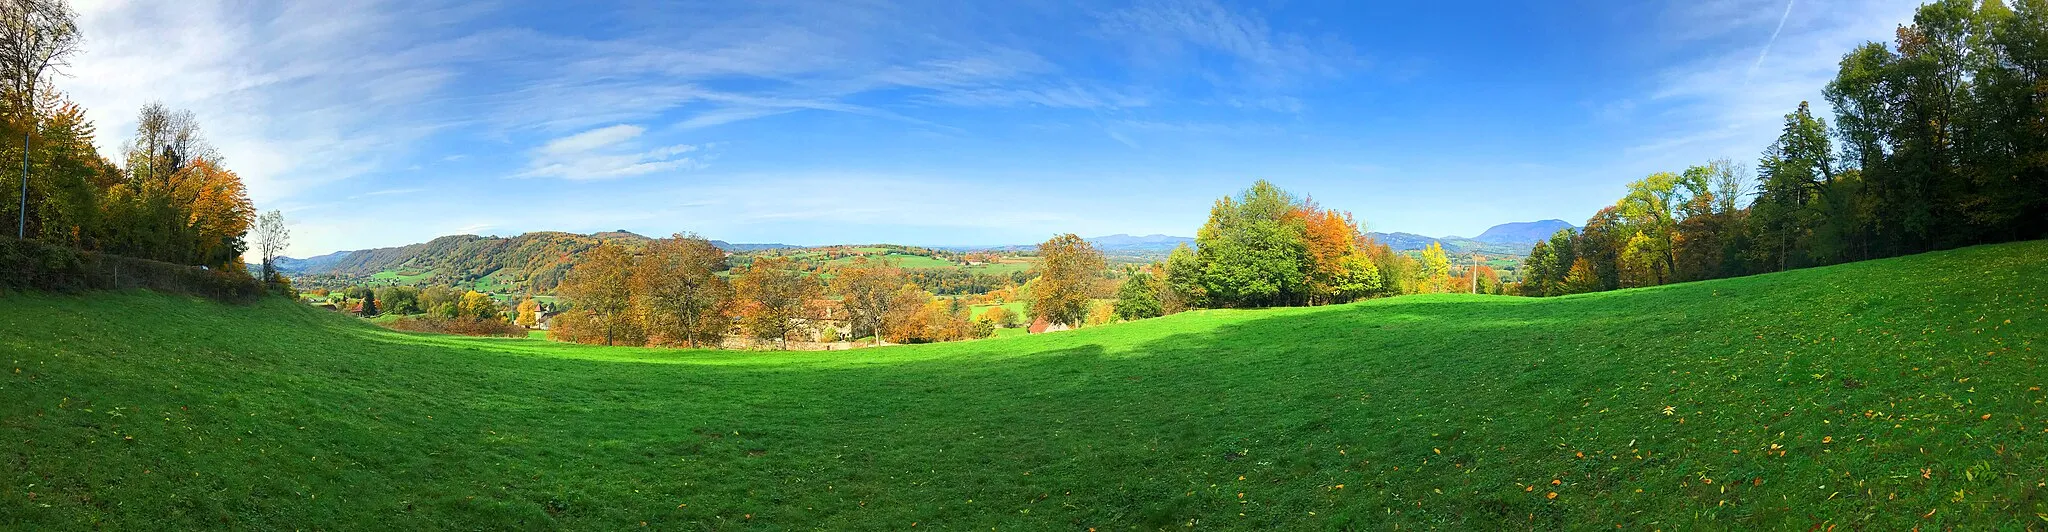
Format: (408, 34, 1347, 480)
(0, 241, 2048, 530)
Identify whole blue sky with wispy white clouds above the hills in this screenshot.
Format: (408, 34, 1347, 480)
(59, 0, 1917, 256)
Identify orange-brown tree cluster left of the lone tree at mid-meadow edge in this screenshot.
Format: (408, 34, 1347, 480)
(549, 235, 1001, 348)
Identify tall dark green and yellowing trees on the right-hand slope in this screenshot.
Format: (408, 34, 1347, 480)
(1520, 0, 2048, 295)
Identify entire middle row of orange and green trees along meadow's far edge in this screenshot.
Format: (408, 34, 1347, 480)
(551, 192, 1501, 346)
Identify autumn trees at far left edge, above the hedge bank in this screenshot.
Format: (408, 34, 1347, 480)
(0, 0, 283, 282)
